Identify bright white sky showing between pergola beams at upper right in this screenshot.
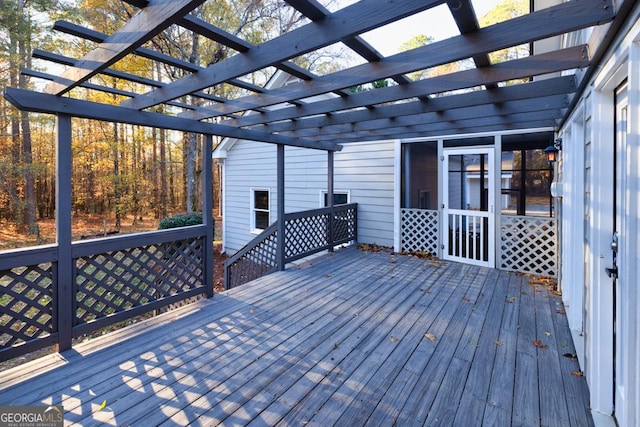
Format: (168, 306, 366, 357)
(362, 0, 503, 56)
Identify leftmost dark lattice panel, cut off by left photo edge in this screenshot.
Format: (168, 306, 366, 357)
(0, 262, 54, 348)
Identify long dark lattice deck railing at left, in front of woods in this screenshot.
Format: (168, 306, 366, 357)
(0, 225, 213, 361)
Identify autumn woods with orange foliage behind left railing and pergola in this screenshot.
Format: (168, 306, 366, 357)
(0, 0, 340, 249)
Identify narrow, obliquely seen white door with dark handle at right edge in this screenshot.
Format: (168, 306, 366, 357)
(609, 83, 631, 424)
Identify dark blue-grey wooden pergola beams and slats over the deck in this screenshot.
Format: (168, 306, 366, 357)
(5, 0, 633, 150)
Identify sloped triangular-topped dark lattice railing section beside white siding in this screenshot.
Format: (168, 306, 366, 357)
(225, 227, 278, 289)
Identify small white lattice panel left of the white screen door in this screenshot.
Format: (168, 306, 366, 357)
(402, 209, 439, 255)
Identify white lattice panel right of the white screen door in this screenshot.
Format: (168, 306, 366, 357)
(500, 215, 558, 277)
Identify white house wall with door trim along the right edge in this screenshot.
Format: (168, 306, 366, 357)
(561, 7, 640, 427)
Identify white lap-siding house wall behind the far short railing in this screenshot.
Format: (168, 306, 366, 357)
(223, 141, 394, 253)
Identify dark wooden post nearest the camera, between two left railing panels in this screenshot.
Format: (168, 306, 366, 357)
(54, 114, 76, 351)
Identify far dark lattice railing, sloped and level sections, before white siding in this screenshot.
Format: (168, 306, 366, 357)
(225, 203, 358, 289)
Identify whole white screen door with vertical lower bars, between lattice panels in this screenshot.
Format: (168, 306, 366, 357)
(442, 148, 495, 268)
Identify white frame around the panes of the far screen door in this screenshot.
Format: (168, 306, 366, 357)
(440, 145, 498, 268)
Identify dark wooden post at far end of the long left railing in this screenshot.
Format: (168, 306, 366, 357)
(202, 135, 215, 298)
